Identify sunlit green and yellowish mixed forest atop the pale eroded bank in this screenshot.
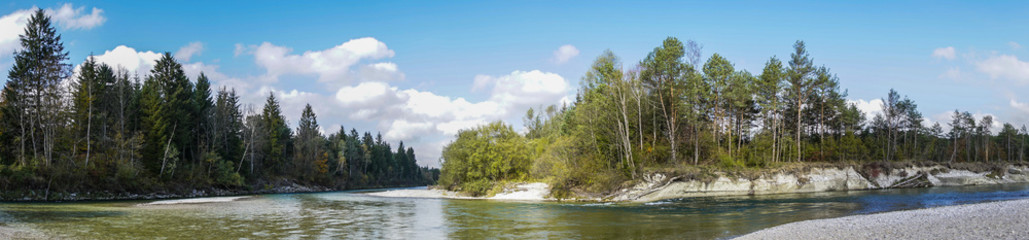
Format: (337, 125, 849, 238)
(439, 37, 1029, 195)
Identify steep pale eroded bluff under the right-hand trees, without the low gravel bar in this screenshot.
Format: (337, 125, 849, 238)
(605, 165, 1029, 202)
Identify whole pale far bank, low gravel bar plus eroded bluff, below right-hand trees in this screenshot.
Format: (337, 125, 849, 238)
(368, 163, 1029, 202)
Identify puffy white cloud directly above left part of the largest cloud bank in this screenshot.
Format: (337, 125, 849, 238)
(246, 37, 394, 82)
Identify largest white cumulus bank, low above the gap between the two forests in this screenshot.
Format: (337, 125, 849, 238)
(325, 70, 570, 166)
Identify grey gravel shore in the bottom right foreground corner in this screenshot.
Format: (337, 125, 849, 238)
(737, 200, 1029, 240)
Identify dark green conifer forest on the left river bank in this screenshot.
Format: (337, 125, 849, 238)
(0, 9, 438, 200)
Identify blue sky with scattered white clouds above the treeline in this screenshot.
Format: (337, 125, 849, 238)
(0, 0, 1029, 167)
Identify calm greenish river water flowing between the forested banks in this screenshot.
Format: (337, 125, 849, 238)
(0, 184, 1029, 239)
